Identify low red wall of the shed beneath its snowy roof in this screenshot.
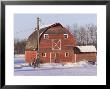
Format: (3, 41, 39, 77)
(76, 53, 97, 62)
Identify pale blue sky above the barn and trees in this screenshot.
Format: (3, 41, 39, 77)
(14, 14, 97, 39)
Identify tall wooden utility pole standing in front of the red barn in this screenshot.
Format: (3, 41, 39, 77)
(34, 17, 40, 68)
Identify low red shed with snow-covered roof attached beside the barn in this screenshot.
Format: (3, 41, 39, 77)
(74, 45, 97, 61)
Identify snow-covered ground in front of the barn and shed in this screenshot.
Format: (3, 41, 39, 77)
(14, 55, 97, 76)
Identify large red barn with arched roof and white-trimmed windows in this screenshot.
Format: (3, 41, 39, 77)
(25, 23, 96, 63)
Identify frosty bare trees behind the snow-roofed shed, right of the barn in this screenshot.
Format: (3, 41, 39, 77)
(67, 24, 97, 46)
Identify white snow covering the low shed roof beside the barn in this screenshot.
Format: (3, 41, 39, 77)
(77, 45, 96, 52)
